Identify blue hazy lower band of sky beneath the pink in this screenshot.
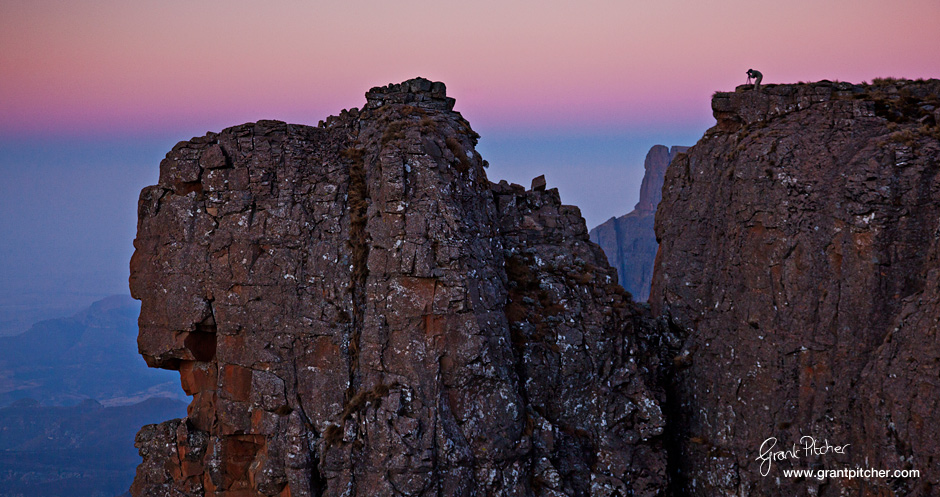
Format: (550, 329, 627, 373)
(0, 127, 703, 335)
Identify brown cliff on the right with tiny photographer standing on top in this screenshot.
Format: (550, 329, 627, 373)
(650, 80, 940, 495)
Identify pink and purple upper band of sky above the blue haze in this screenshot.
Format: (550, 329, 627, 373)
(0, 0, 940, 136)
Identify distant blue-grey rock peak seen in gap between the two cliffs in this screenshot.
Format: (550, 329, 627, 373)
(591, 145, 689, 302)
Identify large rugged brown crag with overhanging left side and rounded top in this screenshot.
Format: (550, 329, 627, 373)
(131, 79, 666, 497)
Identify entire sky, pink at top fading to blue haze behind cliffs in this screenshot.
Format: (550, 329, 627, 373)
(0, 0, 940, 322)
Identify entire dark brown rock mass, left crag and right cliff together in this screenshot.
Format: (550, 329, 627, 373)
(130, 78, 940, 497)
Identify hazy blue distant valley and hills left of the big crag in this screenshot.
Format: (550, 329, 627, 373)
(0, 296, 186, 497)
